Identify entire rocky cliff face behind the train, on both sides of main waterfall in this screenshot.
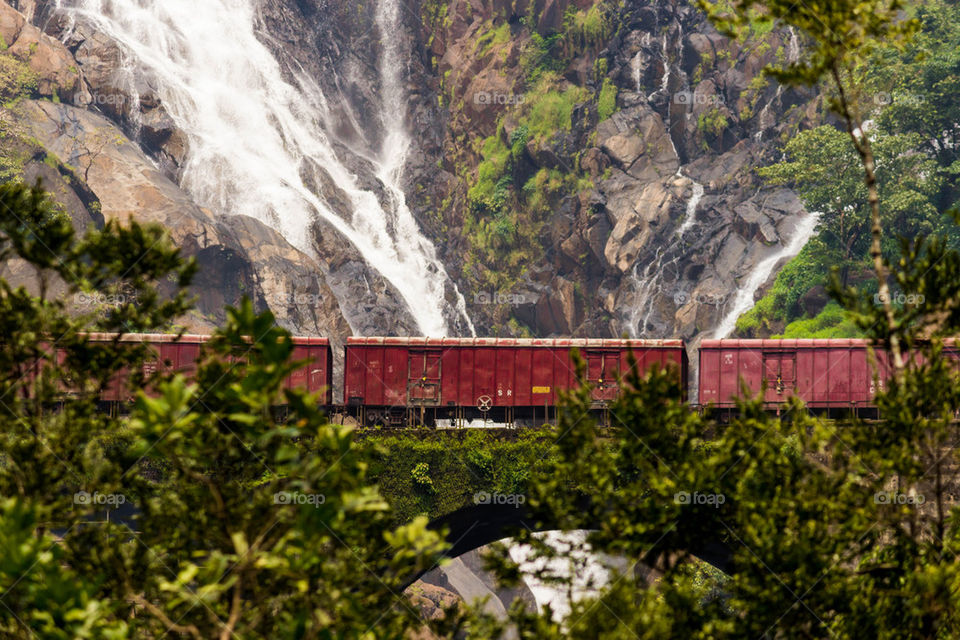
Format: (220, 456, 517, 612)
(0, 0, 820, 356)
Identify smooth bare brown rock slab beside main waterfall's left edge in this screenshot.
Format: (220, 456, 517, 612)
(25, 101, 350, 341)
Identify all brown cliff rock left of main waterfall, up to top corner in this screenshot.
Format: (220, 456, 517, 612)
(0, 3, 349, 360)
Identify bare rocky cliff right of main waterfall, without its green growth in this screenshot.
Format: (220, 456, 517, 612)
(408, 0, 818, 338)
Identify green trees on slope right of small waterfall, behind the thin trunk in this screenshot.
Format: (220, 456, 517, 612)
(737, 0, 960, 337)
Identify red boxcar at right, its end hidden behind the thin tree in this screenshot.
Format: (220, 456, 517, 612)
(699, 339, 908, 414)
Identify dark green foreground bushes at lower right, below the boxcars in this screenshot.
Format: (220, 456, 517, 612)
(489, 332, 960, 639)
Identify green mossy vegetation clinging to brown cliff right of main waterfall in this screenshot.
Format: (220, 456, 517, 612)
(422, 0, 618, 331)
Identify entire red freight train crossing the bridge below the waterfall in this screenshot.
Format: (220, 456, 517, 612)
(43, 334, 960, 426)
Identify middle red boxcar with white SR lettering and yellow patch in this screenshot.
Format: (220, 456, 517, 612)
(344, 338, 687, 425)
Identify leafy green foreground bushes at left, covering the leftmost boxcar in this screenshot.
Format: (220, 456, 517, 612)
(0, 184, 458, 639)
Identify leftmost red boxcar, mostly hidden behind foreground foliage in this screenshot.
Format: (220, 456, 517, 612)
(79, 333, 333, 406)
